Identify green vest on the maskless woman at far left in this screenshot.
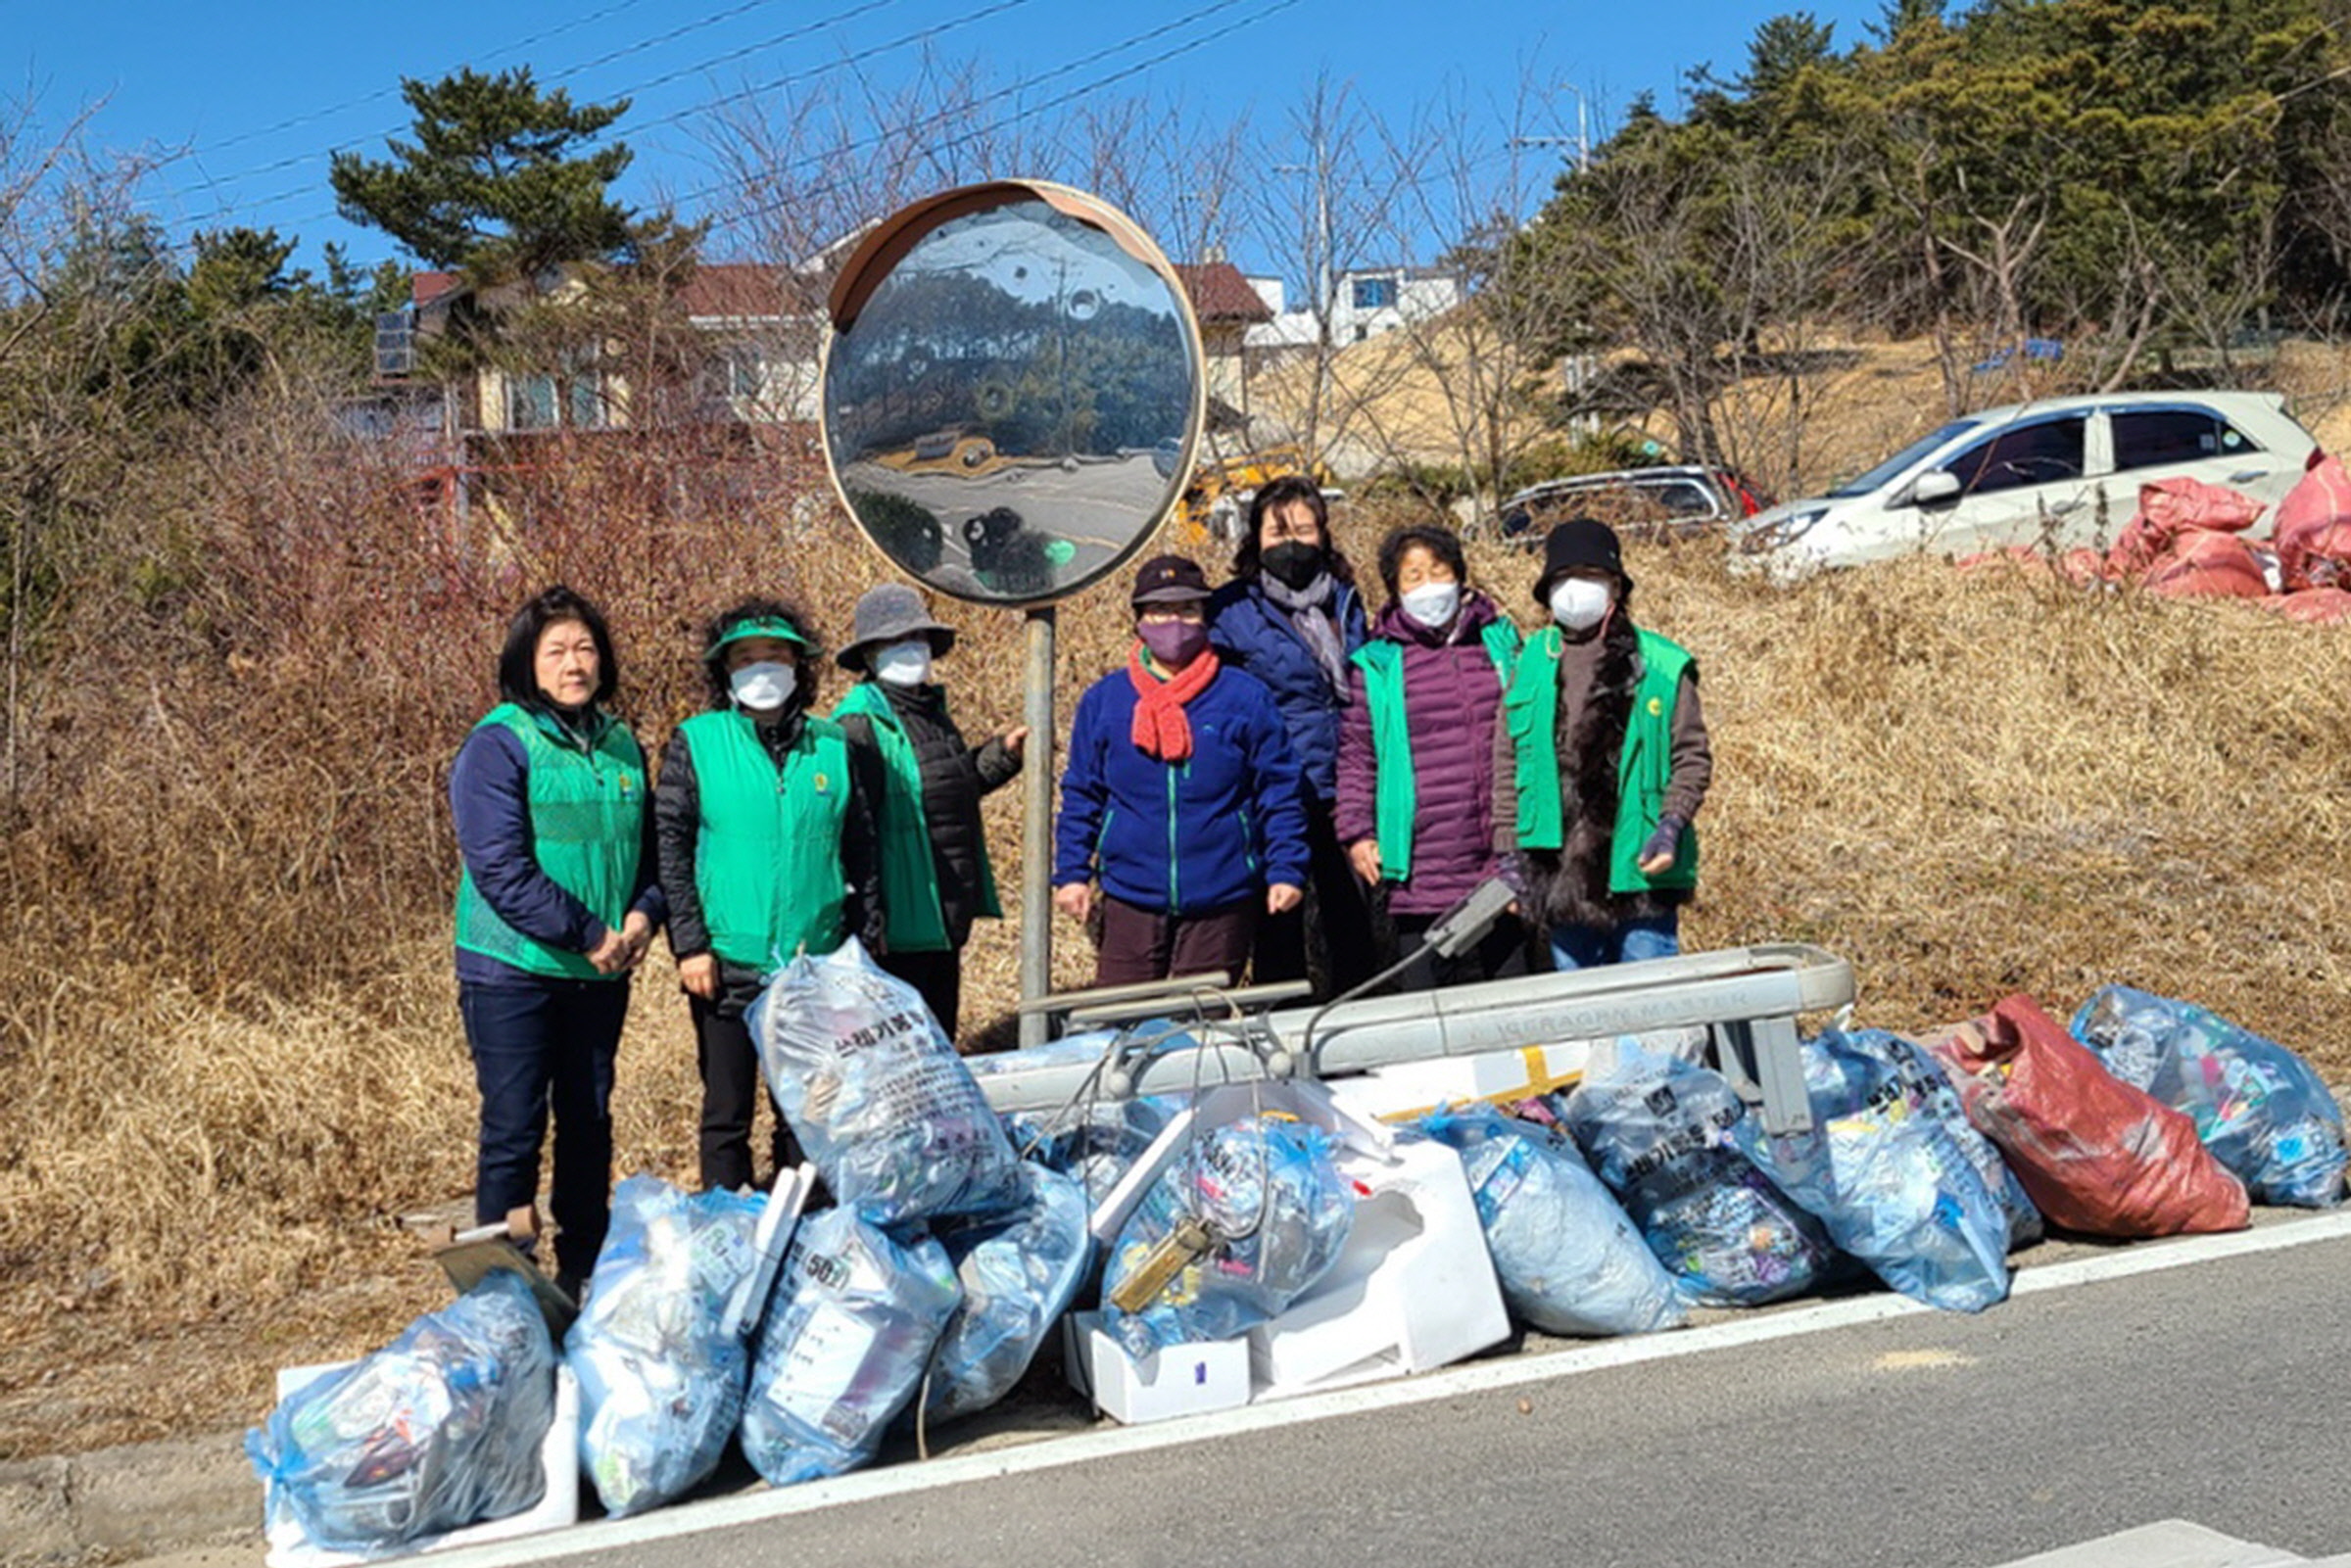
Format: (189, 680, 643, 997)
(456, 703, 645, 980)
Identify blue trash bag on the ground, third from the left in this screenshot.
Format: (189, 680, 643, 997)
(743, 1209, 962, 1486)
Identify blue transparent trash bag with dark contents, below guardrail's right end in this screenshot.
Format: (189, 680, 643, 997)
(1559, 1039, 1839, 1307)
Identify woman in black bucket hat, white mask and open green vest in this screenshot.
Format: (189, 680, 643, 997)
(1495, 517, 1714, 969)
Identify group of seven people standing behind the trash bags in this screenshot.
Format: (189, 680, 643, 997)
(449, 480, 1711, 1286)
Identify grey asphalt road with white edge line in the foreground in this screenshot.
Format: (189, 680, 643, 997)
(472, 1220, 2351, 1568)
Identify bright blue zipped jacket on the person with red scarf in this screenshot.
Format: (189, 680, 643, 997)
(1053, 668, 1307, 915)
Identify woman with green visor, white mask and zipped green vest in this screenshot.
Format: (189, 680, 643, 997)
(653, 599, 882, 1190)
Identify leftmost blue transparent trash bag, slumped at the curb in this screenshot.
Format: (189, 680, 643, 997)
(245, 1269, 554, 1554)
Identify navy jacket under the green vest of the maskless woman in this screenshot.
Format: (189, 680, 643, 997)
(449, 724, 670, 985)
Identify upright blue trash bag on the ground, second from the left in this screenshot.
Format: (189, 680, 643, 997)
(564, 1175, 766, 1516)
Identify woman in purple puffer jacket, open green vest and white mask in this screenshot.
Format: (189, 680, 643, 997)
(1333, 524, 1528, 990)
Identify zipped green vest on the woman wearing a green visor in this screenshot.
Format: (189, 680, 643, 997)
(677, 707, 848, 974)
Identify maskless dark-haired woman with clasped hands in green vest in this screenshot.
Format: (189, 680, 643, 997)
(449, 588, 663, 1296)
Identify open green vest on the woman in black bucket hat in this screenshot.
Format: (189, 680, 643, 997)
(1503, 625, 1698, 893)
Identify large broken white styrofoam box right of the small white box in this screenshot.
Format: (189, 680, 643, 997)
(1248, 1140, 1510, 1399)
